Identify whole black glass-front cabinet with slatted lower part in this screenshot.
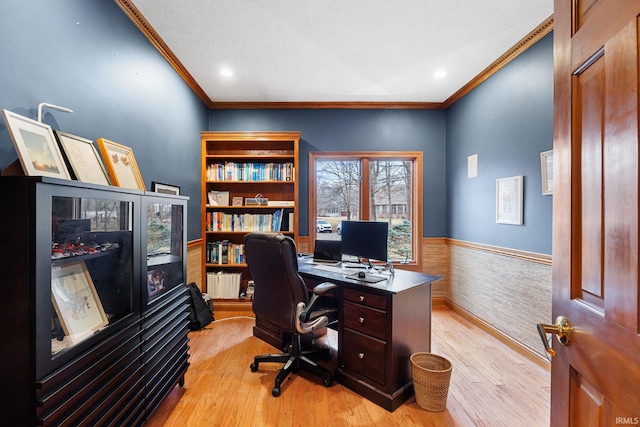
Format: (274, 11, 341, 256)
(0, 177, 188, 426)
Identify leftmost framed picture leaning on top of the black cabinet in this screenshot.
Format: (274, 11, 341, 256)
(2, 110, 70, 179)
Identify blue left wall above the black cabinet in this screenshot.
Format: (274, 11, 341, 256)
(0, 0, 208, 240)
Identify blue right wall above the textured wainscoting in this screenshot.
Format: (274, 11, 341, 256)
(447, 34, 553, 254)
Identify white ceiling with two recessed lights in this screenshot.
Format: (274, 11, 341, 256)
(122, 0, 553, 105)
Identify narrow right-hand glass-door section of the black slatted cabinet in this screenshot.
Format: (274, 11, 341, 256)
(141, 192, 189, 414)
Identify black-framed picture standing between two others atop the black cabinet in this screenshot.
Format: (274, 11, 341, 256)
(53, 130, 111, 185)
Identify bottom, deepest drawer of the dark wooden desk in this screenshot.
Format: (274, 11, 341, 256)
(342, 328, 387, 386)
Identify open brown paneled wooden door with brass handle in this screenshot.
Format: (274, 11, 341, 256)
(551, 0, 640, 426)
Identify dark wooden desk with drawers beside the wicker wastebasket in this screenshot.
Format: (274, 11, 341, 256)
(254, 258, 440, 411)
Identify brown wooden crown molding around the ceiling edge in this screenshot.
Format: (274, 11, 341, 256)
(114, 0, 553, 110)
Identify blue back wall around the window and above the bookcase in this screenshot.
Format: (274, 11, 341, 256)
(209, 110, 446, 237)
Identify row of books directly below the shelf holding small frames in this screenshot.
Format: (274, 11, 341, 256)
(207, 209, 293, 232)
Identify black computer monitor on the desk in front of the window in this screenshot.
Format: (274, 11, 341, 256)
(341, 221, 389, 262)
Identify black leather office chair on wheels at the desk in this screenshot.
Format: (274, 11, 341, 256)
(244, 232, 337, 397)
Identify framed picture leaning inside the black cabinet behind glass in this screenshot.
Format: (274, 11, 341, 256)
(51, 261, 109, 344)
